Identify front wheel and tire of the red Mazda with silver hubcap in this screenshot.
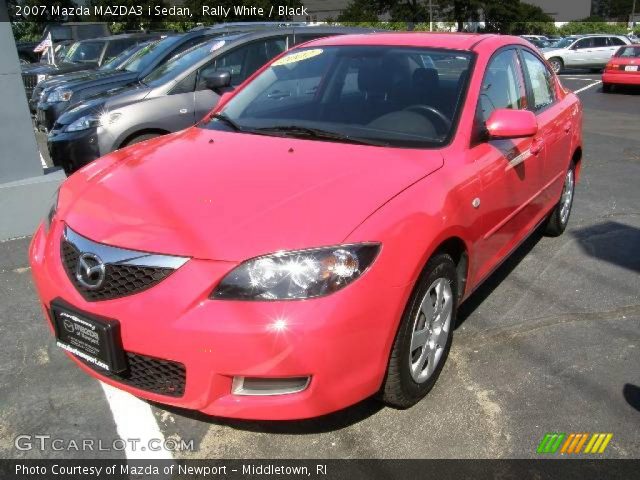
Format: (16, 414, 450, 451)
(380, 253, 458, 409)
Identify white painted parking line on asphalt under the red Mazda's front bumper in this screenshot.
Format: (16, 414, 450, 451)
(100, 382, 173, 460)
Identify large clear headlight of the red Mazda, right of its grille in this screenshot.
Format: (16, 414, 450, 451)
(210, 243, 380, 300)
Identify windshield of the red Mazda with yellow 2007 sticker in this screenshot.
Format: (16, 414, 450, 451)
(200, 46, 472, 148)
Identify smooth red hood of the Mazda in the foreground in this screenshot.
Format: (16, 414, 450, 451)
(58, 127, 443, 261)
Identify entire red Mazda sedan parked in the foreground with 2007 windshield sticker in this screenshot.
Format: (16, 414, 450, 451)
(30, 33, 582, 419)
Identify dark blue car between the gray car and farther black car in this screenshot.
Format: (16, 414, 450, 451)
(36, 23, 288, 130)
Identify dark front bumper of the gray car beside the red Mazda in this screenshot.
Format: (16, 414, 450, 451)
(47, 128, 100, 172)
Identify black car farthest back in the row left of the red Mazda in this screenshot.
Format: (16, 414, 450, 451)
(22, 33, 151, 98)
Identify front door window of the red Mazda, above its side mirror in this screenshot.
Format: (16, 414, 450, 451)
(478, 50, 527, 124)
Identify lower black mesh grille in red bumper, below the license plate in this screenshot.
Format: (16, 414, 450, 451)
(76, 352, 187, 397)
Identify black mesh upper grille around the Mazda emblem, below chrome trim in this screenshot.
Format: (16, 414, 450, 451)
(60, 240, 174, 302)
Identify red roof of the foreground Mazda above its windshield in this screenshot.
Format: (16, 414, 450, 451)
(305, 32, 502, 50)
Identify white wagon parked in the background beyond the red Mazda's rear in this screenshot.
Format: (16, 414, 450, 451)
(542, 34, 631, 73)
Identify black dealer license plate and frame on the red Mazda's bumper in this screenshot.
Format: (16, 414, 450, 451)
(50, 299, 127, 373)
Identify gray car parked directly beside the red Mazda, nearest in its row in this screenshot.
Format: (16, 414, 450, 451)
(48, 26, 372, 172)
